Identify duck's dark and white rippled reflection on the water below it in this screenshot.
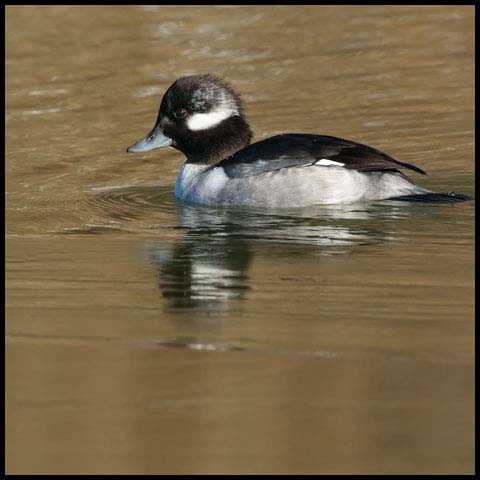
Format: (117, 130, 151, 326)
(146, 202, 402, 311)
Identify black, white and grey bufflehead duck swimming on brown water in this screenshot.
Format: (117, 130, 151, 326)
(127, 75, 468, 207)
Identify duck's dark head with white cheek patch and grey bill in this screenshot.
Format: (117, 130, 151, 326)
(127, 75, 252, 164)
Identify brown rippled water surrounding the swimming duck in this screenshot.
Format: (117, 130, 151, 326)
(6, 6, 474, 473)
